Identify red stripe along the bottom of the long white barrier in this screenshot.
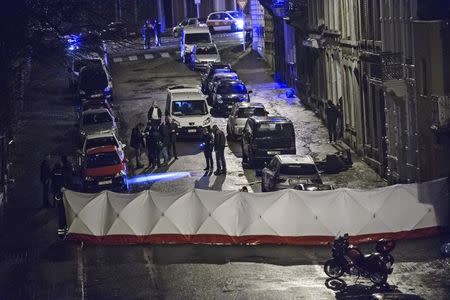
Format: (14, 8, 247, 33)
(66, 227, 442, 246)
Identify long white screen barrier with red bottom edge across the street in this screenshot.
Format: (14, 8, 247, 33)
(64, 179, 448, 245)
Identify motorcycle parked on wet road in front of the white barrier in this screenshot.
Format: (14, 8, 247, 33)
(324, 234, 395, 285)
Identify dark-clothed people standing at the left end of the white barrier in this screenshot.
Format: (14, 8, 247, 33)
(40, 155, 73, 230)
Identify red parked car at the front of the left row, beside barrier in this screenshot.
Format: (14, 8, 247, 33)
(81, 145, 127, 192)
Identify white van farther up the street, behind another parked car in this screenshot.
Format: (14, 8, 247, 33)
(180, 27, 212, 63)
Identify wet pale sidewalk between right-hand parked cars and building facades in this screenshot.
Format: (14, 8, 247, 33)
(233, 51, 386, 189)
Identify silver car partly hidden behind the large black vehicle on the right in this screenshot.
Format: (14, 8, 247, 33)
(227, 102, 268, 140)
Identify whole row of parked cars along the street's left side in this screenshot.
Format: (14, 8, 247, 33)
(68, 53, 127, 192)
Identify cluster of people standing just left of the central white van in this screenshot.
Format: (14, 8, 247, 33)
(130, 102, 178, 168)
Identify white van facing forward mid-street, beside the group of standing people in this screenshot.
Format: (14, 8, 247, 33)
(166, 86, 211, 137)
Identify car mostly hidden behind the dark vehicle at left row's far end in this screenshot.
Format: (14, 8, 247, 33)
(67, 52, 107, 90)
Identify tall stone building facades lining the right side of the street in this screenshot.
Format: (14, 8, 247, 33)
(253, 0, 450, 183)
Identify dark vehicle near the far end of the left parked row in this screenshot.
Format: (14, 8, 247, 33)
(78, 66, 113, 102)
